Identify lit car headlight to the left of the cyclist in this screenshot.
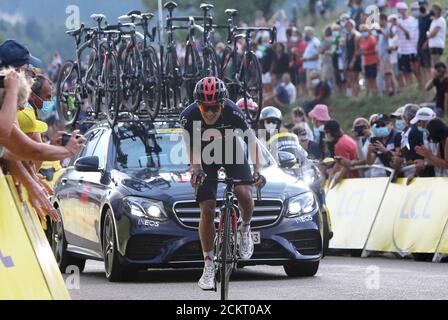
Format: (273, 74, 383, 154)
(123, 197, 168, 221)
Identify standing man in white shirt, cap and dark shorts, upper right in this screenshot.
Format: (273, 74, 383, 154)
(391, 2, 422, 86)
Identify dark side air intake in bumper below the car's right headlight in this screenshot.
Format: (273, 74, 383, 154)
(280, 230, 322, 256)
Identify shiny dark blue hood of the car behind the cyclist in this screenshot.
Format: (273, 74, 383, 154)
(114, 166, 310, 203)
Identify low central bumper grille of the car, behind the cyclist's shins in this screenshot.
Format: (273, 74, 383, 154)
(171, 240, 289, 262)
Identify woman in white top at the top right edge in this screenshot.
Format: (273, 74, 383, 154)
(427, 3, 446, 65)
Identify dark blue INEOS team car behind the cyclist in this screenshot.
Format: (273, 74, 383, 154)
(50, 122, 323, 281)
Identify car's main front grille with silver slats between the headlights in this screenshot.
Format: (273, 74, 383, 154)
(173, 199, 283, 229)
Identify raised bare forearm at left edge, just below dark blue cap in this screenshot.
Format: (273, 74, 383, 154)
(0, 71, 20, 139)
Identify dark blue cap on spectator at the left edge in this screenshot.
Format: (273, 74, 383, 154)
(0, 39, 43, 68)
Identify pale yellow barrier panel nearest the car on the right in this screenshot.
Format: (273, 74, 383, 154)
(326, 178, 389, 249)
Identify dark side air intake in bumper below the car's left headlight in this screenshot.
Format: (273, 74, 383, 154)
(126, 235, 179, 260)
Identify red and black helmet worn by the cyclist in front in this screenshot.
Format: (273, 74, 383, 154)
(194, 77, 227, 104)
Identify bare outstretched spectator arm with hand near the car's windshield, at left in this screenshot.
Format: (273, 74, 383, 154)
(0, 125, 85, 161)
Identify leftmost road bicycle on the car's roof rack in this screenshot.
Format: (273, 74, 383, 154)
(56, 14, 120, 127)
